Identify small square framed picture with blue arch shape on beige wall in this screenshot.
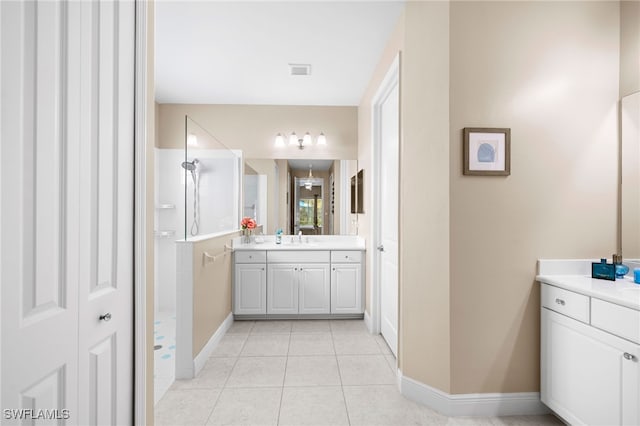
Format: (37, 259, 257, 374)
(462, 127, 511, 176)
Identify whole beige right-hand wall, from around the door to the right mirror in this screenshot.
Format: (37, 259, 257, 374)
(358, 2, 620, 394)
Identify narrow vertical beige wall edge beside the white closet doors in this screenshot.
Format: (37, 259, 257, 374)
(145, 0, 157, 424)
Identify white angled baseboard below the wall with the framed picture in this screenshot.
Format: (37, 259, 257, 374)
(398, 372, 550, 417)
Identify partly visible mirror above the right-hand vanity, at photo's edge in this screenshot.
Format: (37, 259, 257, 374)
(620, 92, 640, 259)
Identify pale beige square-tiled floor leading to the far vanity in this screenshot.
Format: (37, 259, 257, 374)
(155, 320, 562, 426)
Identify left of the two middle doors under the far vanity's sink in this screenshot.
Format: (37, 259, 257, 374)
(267, 263, 299, 314)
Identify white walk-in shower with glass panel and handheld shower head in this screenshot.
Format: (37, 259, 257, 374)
(154, 116, 242, 402)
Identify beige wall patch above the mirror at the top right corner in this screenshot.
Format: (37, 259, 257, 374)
(620, 1, 640, 98)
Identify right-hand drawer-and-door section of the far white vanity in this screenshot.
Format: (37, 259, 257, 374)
(331, 251, 364, 314)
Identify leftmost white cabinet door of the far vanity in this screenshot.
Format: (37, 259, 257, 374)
(233, 264, 267, 315)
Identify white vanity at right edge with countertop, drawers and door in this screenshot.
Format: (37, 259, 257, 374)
(536, 260, 640, 425)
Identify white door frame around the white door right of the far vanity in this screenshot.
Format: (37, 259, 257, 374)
(368, 52, 400, 340)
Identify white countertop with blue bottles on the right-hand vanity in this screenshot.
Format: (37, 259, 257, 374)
(536, 259, 640, 311)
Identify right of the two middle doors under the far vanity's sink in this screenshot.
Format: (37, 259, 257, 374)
(298, 263, 331, 314)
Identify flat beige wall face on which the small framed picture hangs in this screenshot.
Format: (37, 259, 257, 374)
(448, 2, 619, 393)
